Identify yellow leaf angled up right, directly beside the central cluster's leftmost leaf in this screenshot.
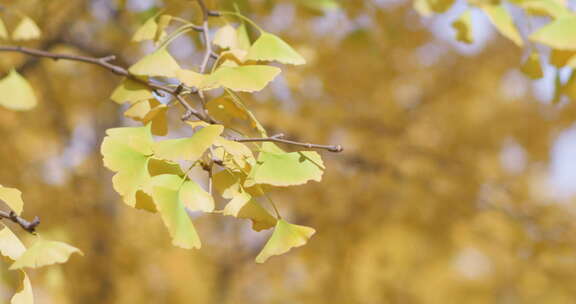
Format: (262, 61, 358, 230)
(153, 125, 224, 161)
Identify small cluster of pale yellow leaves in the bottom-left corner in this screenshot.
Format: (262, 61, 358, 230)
(0, 185, 82, 304)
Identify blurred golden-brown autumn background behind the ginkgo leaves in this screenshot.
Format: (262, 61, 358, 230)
(0, 0, 576, 304)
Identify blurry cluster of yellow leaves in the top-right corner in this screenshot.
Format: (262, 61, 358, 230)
(414, 0, 576, 96)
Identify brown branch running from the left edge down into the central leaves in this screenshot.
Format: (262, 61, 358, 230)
(0, 46, 214, 124)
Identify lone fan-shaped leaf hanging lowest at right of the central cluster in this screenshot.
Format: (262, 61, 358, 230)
(256, 219, 316, 263)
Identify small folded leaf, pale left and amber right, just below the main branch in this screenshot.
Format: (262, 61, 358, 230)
(124, 99, 168, 136)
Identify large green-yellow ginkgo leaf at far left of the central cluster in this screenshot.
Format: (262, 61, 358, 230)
(101, 125, 152, 207)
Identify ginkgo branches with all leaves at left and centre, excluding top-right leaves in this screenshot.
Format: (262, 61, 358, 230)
(0, 0, 343, 303)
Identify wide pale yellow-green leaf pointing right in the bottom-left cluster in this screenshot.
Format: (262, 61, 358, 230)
(10, 238, 84, 270)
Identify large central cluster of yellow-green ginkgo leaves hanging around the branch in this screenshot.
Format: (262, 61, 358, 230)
(102, 13, 324, 262)
